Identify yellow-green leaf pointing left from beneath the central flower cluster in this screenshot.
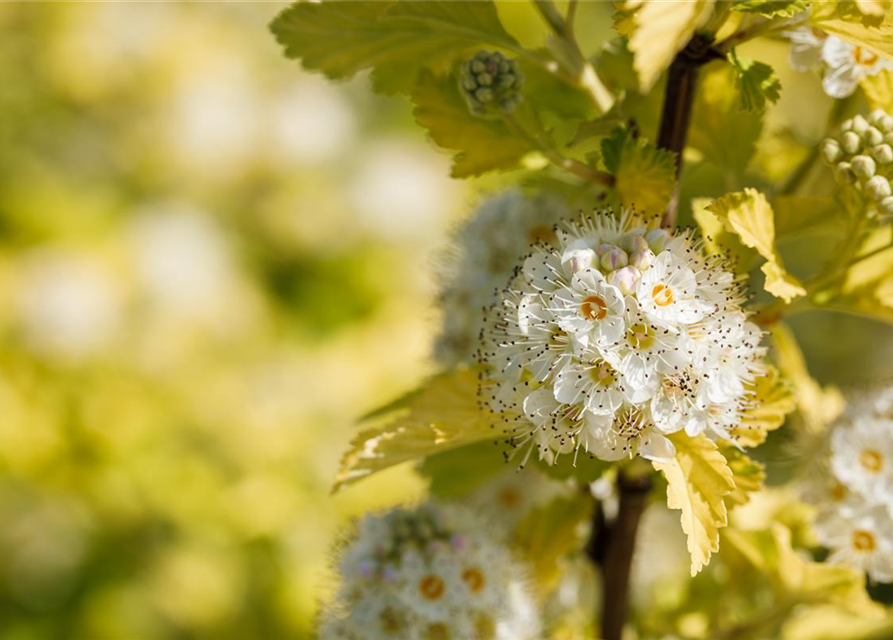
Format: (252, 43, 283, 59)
(334, 369, 499, 491)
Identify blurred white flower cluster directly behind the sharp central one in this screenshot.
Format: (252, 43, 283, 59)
(434, 189, 569, 366)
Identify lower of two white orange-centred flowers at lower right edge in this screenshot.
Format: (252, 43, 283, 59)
(816, 504, 893, 582)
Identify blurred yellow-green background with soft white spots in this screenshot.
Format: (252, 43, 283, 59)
(0, 2, 880, 640)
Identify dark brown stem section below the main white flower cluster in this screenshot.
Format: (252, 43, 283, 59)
(589, 472, 651, 640)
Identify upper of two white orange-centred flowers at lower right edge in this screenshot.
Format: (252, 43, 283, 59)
(831, 416, 893, 505)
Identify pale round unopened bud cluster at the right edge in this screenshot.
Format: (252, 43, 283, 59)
(821, 109, 893, 216)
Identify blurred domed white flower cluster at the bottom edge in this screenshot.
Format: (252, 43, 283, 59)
(320, 503, 539, 640)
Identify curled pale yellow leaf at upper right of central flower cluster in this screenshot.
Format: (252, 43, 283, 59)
(707, 188, 806, 302)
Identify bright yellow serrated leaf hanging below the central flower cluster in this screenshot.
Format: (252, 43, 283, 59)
(654, 433, 735, 576)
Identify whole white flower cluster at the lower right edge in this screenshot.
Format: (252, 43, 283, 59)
(816, 390, 893, 582)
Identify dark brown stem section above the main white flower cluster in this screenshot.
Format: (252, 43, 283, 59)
(657, 35, 723, 229)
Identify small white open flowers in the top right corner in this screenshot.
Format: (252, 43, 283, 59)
(784, 25, 893, 98)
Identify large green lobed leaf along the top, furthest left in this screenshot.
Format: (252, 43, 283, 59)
(271, 0, 518, 92)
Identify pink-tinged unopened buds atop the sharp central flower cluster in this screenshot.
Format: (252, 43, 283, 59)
(571, 229, 670, 295)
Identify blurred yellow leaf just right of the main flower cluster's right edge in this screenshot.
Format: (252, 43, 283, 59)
(772, 323, 844, 433)
